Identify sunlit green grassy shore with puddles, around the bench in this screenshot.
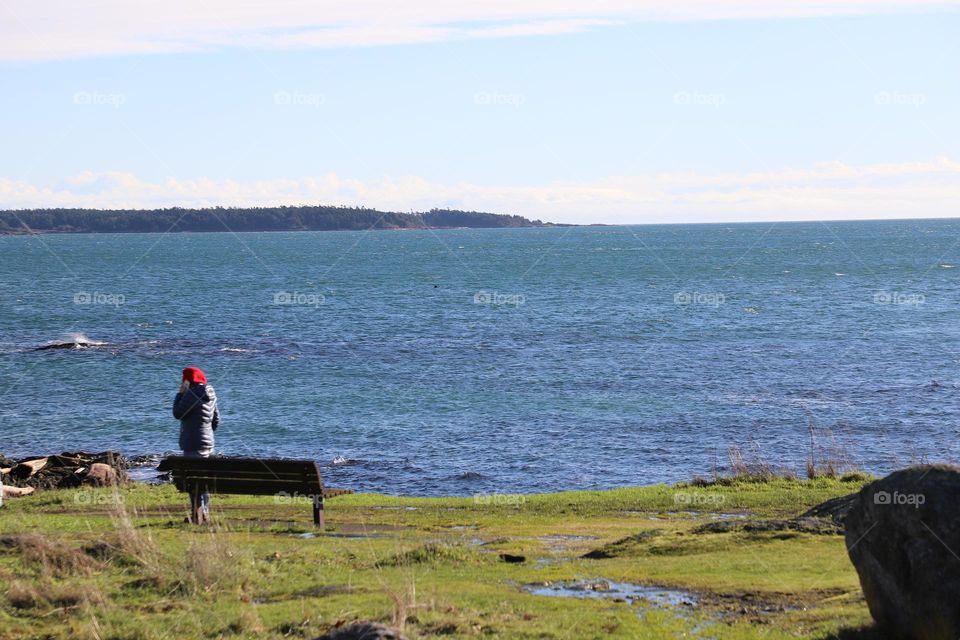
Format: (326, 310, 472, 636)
(0, 478, 869, 640)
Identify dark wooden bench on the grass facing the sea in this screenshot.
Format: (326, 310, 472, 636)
(157, 456, 353, 528)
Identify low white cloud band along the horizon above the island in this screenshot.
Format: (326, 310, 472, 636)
(0, 158, 960, 224)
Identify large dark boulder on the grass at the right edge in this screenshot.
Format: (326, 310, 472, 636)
(846, 465, 960, 640)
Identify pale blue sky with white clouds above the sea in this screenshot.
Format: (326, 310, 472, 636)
(0, 0, 960, 224)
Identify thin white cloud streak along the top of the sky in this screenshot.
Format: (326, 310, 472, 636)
(0, 0, 956, 60)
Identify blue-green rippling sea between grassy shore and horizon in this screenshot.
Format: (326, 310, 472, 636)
(0, 221, 960, 495)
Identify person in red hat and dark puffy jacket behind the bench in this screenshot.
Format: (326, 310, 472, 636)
(173, 367, 220, 524)
